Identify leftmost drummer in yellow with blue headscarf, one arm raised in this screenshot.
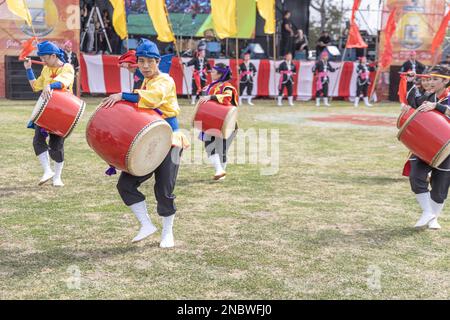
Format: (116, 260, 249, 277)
(24, 41, 75, 187)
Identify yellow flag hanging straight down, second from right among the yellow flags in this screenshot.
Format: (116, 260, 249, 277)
(211, 0, 237, 39)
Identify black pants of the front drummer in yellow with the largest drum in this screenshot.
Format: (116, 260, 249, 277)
(117, 147, 183, 217)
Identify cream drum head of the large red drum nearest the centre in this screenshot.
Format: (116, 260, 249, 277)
(125, 120, 176, 177)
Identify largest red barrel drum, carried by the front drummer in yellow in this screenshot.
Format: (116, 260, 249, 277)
(86, 101, 172, 176)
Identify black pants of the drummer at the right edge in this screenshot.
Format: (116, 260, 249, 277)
(409, 156, 450, 203)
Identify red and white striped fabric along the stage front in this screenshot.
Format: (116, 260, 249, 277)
(81, 54, 374, 100)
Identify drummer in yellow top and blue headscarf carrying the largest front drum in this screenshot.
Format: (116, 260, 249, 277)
(102, 39, 189, 248)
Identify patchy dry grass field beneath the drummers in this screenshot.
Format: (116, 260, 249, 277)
(0, 98, 450, 299)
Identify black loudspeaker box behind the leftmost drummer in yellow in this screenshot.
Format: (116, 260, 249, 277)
(5, 56, 42, 100)
